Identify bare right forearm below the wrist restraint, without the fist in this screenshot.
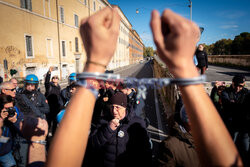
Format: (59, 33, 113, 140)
(180, 85, 241, 166)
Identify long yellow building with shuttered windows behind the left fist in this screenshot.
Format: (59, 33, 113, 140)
(0, 0, 144, 80)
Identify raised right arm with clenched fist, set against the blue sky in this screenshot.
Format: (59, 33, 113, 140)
(151, 10, 242, 166)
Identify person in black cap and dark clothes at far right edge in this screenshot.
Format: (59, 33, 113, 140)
(221, 75, 249, 163)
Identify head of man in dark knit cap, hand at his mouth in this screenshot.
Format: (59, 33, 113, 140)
(109, 92, 127, 120)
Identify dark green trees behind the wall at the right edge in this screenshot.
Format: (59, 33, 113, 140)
(204, 32, 250, 55)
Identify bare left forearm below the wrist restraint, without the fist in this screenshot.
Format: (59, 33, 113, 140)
(47, 88, 95, 167)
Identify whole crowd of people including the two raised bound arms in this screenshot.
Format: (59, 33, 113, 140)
(0, 7, 250, 167)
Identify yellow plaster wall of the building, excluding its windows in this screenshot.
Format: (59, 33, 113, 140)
(0, 0, 143, 80)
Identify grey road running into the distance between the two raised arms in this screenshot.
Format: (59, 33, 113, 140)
(115, 61, 167, 162)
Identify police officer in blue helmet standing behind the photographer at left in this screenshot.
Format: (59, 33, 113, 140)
(16, 74, 49, 119)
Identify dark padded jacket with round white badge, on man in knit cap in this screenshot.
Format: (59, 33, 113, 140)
(85, 111, 152, 167)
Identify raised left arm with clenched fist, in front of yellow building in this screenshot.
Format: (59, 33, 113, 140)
(47, 7, 120, 167)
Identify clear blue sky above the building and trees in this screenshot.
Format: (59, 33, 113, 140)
(109, 0, 250, 48)
